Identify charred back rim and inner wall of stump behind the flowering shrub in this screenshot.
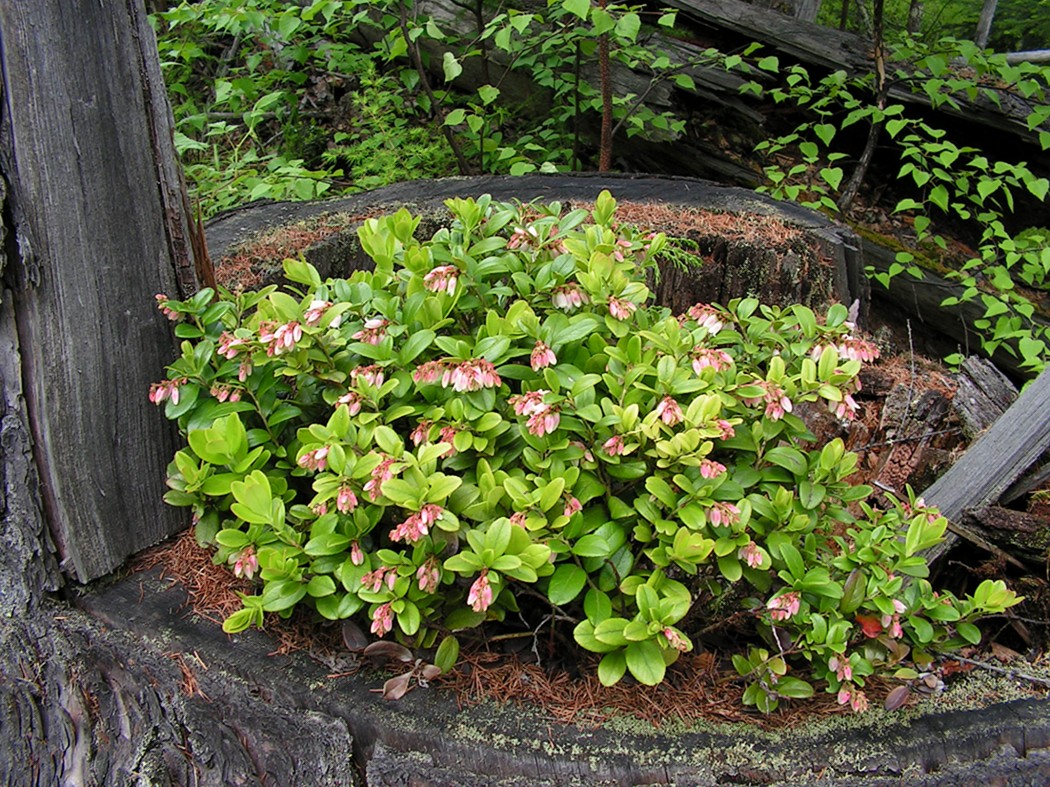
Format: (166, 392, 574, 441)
(208, 175, 868, 315)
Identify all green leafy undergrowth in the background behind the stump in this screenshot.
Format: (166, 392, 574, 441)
(153, 0, 1050, 375)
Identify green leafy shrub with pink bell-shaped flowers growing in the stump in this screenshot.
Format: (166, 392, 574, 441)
(150, 193, 1019, 710)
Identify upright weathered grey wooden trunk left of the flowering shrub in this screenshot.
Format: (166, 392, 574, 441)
(0, 0, 192, 581)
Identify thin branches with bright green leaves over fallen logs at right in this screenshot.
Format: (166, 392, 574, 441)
(748, 40, 1050, 374)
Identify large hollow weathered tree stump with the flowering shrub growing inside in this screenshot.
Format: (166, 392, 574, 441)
(8, 169, 1050, 786)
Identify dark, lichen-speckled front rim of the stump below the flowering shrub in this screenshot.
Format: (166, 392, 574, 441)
(59, 574, 1050, 787)
